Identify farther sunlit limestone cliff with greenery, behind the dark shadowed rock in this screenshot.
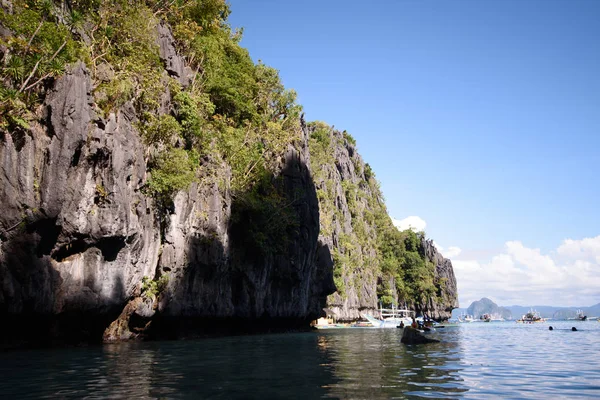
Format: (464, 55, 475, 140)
(310, 123, 458, 321)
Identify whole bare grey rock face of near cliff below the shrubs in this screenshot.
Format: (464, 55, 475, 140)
(0, 30, 335, 341)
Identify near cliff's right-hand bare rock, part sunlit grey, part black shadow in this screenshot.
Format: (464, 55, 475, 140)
(150, 123, 335, 336)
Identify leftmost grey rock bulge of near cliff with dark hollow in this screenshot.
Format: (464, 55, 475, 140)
(0, 64, 160, 344)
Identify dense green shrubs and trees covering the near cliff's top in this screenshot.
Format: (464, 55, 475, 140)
(0, 0, 301, 255)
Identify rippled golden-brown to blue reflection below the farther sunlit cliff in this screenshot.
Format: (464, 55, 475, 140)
(319, 329, 468, 399)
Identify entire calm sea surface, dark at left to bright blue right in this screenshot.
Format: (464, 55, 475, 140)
(0, 321, 600, 399)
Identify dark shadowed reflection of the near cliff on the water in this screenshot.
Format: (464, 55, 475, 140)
(0, 333, 333, 399)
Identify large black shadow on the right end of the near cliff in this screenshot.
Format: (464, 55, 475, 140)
(151, 150, 335, 338)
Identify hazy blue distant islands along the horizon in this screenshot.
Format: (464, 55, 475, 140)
(452, 297, 600, 320)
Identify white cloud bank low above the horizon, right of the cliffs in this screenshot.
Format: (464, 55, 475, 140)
(452, 236, 600, 307)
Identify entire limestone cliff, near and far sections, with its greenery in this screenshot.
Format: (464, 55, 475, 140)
(0, 0, 456, 341)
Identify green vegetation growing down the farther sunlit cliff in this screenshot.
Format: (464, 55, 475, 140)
(309, 122, 443, 305)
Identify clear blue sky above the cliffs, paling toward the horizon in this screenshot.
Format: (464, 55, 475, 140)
(230, 0, 600, 306)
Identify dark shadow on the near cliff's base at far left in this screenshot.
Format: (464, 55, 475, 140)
(0, 219, 125, 348)
